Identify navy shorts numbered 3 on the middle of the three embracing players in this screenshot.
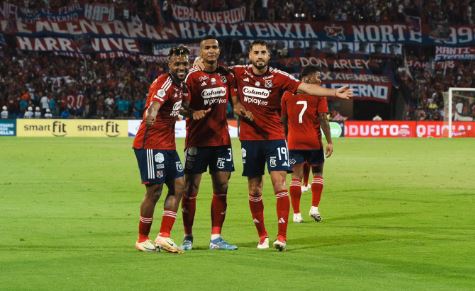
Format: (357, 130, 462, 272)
(185, 146, 234, 174)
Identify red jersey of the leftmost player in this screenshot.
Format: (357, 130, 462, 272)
(133, 73, 186, 150)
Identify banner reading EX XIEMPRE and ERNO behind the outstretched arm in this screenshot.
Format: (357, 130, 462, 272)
(320, 71, 392, 102)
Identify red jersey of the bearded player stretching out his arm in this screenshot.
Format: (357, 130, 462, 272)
(233, 65, 301, 140)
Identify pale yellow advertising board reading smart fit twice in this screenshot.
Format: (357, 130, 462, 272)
(17, 119, 128, 137)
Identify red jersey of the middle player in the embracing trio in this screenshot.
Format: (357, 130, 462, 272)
(184, 69, 235, 148)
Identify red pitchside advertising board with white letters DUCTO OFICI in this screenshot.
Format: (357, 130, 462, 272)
(345, 121, 475, 138)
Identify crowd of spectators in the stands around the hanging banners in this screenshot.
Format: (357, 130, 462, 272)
(0, 0, 475, 120)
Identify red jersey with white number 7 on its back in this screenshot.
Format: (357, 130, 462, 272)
(282, 92, 328, 150)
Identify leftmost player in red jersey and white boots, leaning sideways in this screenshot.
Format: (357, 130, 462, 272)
(133, 46, 190, 253)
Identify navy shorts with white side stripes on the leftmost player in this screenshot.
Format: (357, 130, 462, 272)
(134, 149, 184, 184)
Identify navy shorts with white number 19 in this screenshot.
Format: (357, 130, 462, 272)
(241, 139, 290, 177)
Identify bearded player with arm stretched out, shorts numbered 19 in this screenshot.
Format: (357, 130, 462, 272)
(233, 41, 353, 251)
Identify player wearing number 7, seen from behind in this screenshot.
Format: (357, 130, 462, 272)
(282, 66, 333, 223)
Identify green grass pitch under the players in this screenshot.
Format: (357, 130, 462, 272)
(0, 138, 475, 290)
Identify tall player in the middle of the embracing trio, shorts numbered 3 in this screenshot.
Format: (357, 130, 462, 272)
(182, 37, 237, 250)
